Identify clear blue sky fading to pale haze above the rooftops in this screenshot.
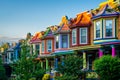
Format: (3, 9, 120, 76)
(0, 0, 106, 41)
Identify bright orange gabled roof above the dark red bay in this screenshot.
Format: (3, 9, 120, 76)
(70, 11, 92, 28)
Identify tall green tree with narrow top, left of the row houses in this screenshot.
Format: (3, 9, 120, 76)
(13, 44, 45, 80)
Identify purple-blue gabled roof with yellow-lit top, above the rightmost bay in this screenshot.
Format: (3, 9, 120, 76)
(92, 0, 119, 19)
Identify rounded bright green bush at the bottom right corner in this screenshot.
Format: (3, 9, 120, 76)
(94, 55, 120, 80)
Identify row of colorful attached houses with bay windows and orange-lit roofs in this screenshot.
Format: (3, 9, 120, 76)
(30, 0, 120, 74)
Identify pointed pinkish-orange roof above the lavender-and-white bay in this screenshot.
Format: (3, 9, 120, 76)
(56, 16, 70, 33)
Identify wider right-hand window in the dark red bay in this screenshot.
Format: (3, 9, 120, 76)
(80, 28, 87, 44)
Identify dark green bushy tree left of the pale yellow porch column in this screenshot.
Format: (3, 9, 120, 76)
(57, 55, 83, 80)
